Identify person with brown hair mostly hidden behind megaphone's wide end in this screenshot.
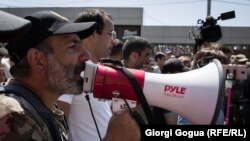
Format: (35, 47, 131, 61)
(177, 47, 229, 125)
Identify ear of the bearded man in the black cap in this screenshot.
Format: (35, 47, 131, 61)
(27, 48, 47, 73)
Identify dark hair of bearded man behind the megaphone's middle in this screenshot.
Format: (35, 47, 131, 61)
(122, 36, 152, 59)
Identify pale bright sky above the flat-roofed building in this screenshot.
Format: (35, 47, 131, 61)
(0, 0, 250, 27)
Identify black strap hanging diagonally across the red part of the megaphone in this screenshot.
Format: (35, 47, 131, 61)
(121, 67, 154, 124)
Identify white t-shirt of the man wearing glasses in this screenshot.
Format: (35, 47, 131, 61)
(59, 93, 112, 141)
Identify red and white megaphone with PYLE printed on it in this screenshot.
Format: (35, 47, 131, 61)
(83, 59, 224, 125)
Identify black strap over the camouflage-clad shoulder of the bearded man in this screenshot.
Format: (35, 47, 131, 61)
(3, 84, 62, 141)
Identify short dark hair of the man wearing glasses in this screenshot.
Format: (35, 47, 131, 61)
(75, 9, 112, 34)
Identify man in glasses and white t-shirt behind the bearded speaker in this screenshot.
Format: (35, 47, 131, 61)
(58, 9, 116, 141)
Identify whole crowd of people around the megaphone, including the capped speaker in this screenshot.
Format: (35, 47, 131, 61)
(0, 9, 250, 141)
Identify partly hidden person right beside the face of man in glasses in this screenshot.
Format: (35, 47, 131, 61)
(109, 39, 123, 60)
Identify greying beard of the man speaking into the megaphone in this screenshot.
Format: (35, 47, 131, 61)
(47, 55, 85, 95)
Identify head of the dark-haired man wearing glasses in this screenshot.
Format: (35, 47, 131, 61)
(75, 9, 117, 63)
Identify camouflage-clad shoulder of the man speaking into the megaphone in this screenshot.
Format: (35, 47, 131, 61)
(0, 94, 48, 141)
